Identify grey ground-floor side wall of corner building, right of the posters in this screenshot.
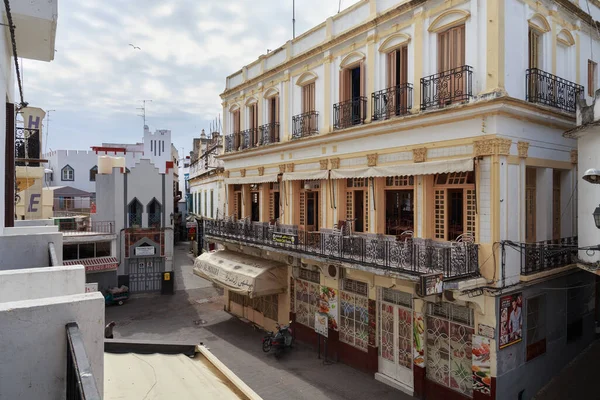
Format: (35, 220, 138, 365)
(496, 271, 595, 400)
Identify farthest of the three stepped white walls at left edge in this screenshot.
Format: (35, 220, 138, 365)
(0, 228, 63, 270)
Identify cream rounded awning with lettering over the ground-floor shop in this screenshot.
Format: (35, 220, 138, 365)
(194, 250, 287, 298)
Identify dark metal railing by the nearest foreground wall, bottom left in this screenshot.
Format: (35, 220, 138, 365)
(66, 322, 102, 400)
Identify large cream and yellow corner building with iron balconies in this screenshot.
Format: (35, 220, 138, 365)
(196, 0, 600, 399)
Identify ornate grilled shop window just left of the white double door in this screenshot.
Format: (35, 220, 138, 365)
(339, 279, 369, 351)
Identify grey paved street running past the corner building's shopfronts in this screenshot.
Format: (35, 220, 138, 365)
(106, 243, 412, 400)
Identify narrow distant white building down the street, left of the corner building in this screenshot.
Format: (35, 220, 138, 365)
(188, 129, 226, 218)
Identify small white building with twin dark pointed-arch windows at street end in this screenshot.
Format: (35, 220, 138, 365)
(93, 157, 174, 292)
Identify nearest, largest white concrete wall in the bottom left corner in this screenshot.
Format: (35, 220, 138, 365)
(0, 292, 104, 399)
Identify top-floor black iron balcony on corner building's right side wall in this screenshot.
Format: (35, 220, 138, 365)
(525, 68, 583, 113)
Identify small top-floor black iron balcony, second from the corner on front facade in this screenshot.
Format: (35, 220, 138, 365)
(371, 83, 413, 121)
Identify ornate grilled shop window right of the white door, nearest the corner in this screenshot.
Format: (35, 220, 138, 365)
(426, 303, 474, 397)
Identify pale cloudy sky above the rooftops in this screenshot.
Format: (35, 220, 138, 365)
(22, 0, 358, 156)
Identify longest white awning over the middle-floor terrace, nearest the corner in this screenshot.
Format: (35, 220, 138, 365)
(331, 158, 473, 179)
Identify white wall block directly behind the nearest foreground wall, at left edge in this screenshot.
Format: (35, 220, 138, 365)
(0, 266, 85, 303)
